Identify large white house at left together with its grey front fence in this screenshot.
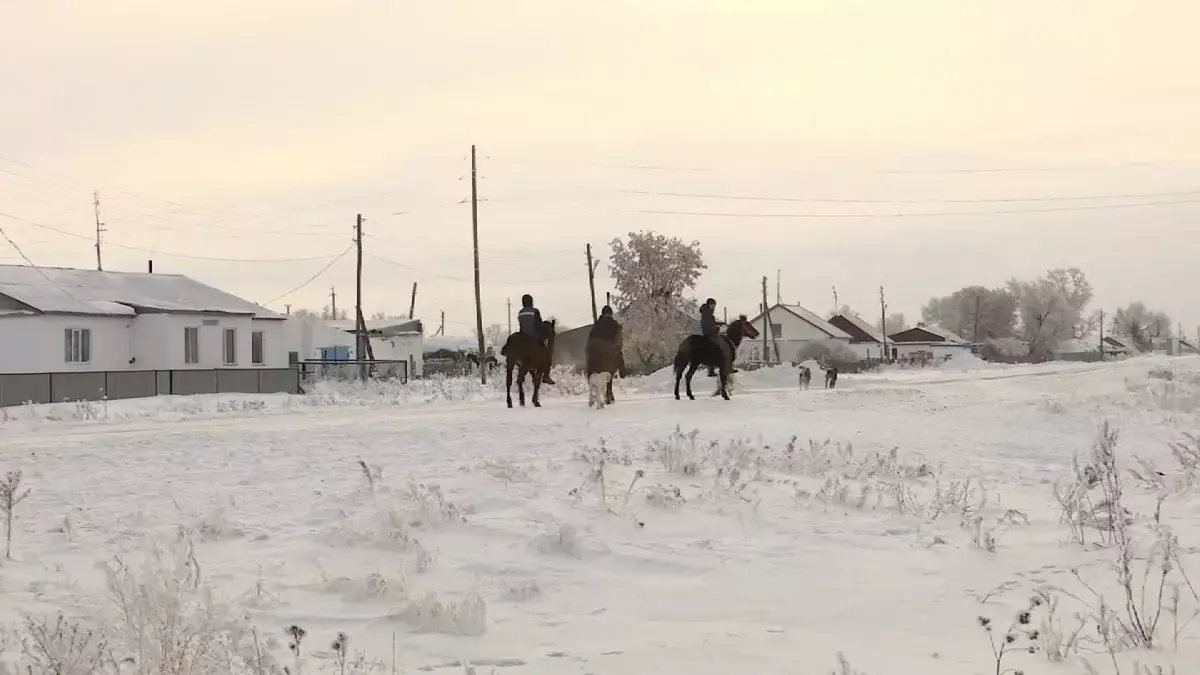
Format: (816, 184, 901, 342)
(0, 265, 296, 405)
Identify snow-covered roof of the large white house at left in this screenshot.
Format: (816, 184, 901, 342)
(0, 265, 283, 318)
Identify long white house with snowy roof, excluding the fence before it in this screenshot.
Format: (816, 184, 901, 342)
(0, 265, 288, 374)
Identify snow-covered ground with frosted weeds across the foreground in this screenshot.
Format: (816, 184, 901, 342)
(0, 358, 1200, 675)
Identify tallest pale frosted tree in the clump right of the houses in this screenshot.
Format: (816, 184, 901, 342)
(1008, 268, 1094, 360)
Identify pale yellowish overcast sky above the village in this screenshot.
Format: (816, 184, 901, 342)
(0, 0, 1200, 334)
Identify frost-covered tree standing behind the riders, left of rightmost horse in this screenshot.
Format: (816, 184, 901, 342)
(608, 231, 707, 371)
